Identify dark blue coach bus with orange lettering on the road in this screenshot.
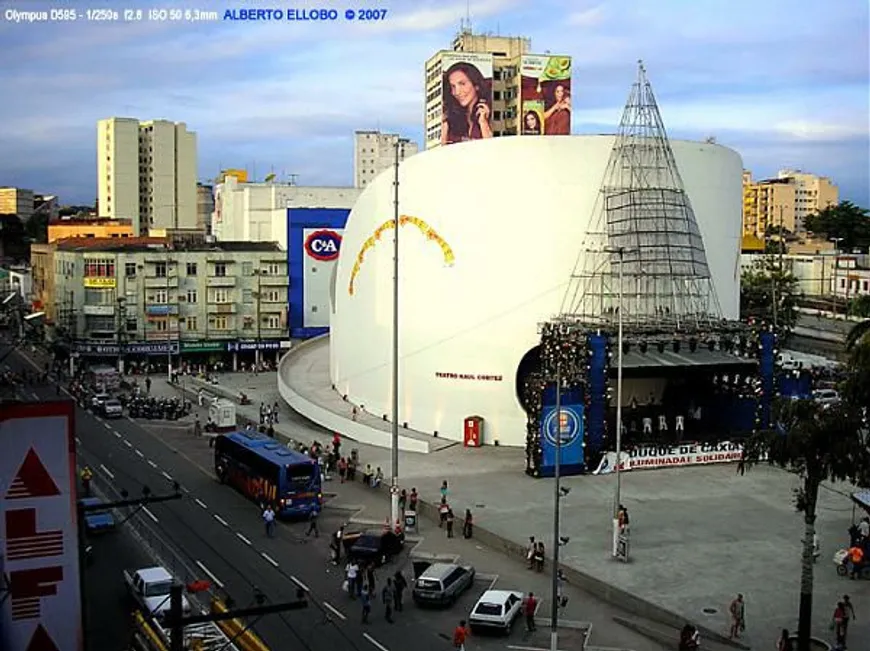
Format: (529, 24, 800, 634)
(214, 432, 323, 518)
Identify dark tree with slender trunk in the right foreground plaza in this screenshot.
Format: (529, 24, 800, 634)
(744, 400, 870, 651)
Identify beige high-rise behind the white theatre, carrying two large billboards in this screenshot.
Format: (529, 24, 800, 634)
(424, 29, 532, 149)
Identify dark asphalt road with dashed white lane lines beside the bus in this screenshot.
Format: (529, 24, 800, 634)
(7, 355, 532, 651)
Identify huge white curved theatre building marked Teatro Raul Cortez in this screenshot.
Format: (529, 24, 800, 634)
(330, 136, 743, 446)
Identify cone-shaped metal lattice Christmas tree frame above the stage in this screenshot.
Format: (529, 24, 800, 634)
(557, 61, 722, 332)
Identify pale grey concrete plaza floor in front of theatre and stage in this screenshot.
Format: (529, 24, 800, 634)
(187, 338, 870, 649)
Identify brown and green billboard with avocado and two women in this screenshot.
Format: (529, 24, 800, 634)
(517, 54, 571, 136)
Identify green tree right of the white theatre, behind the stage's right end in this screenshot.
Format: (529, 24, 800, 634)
(740, 255, 800, 333)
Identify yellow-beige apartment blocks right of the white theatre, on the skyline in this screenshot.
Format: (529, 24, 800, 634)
(743, 170, 839, 239)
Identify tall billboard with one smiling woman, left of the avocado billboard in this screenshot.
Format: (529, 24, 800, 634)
(441, 52, 492, 145)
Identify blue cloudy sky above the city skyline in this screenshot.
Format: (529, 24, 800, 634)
(0, 0, 870, 206)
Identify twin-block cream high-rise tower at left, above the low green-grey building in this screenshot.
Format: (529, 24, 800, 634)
(97, 118, 197, 235)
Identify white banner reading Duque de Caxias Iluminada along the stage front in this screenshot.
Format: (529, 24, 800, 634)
(592, 441, 743, 475)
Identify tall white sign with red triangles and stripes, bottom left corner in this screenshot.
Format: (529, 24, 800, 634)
(0, 402, 82, 651)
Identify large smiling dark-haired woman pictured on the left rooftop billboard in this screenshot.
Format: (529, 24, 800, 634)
(441, 61, 492, 145)
